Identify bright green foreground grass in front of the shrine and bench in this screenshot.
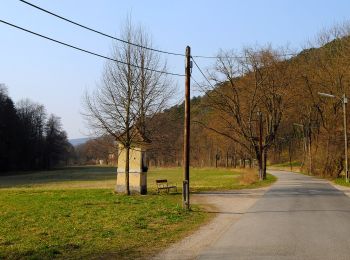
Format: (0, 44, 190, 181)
(0, 189, 209, 259)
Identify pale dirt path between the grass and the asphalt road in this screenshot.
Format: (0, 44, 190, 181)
(154, 187, 269, 259)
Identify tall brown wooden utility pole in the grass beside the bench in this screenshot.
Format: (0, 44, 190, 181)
(182, 46, 191, 210)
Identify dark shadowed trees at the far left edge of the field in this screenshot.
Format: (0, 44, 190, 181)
(0, 84, 73, 173)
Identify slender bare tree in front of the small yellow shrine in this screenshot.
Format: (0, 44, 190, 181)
(84, 19, 172, 194)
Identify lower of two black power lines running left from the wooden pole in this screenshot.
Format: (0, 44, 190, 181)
(0, 20, 185, 77)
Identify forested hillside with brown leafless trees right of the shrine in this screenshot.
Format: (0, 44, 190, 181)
(149, 27, 350, 179)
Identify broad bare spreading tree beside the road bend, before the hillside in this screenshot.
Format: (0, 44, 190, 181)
(197, 48, 290, 179)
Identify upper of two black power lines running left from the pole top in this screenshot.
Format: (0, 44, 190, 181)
(19, 0, 185, 56)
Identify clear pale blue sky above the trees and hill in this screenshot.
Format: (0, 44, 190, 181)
(0, 0, 350, 138)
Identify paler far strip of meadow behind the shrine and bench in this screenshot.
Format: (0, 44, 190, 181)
(0, 166, 274, 192)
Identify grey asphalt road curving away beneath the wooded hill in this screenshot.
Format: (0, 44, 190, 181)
(198, 171, 350, 259)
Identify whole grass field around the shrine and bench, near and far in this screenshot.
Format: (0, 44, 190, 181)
(0, 167, 274, 259)
